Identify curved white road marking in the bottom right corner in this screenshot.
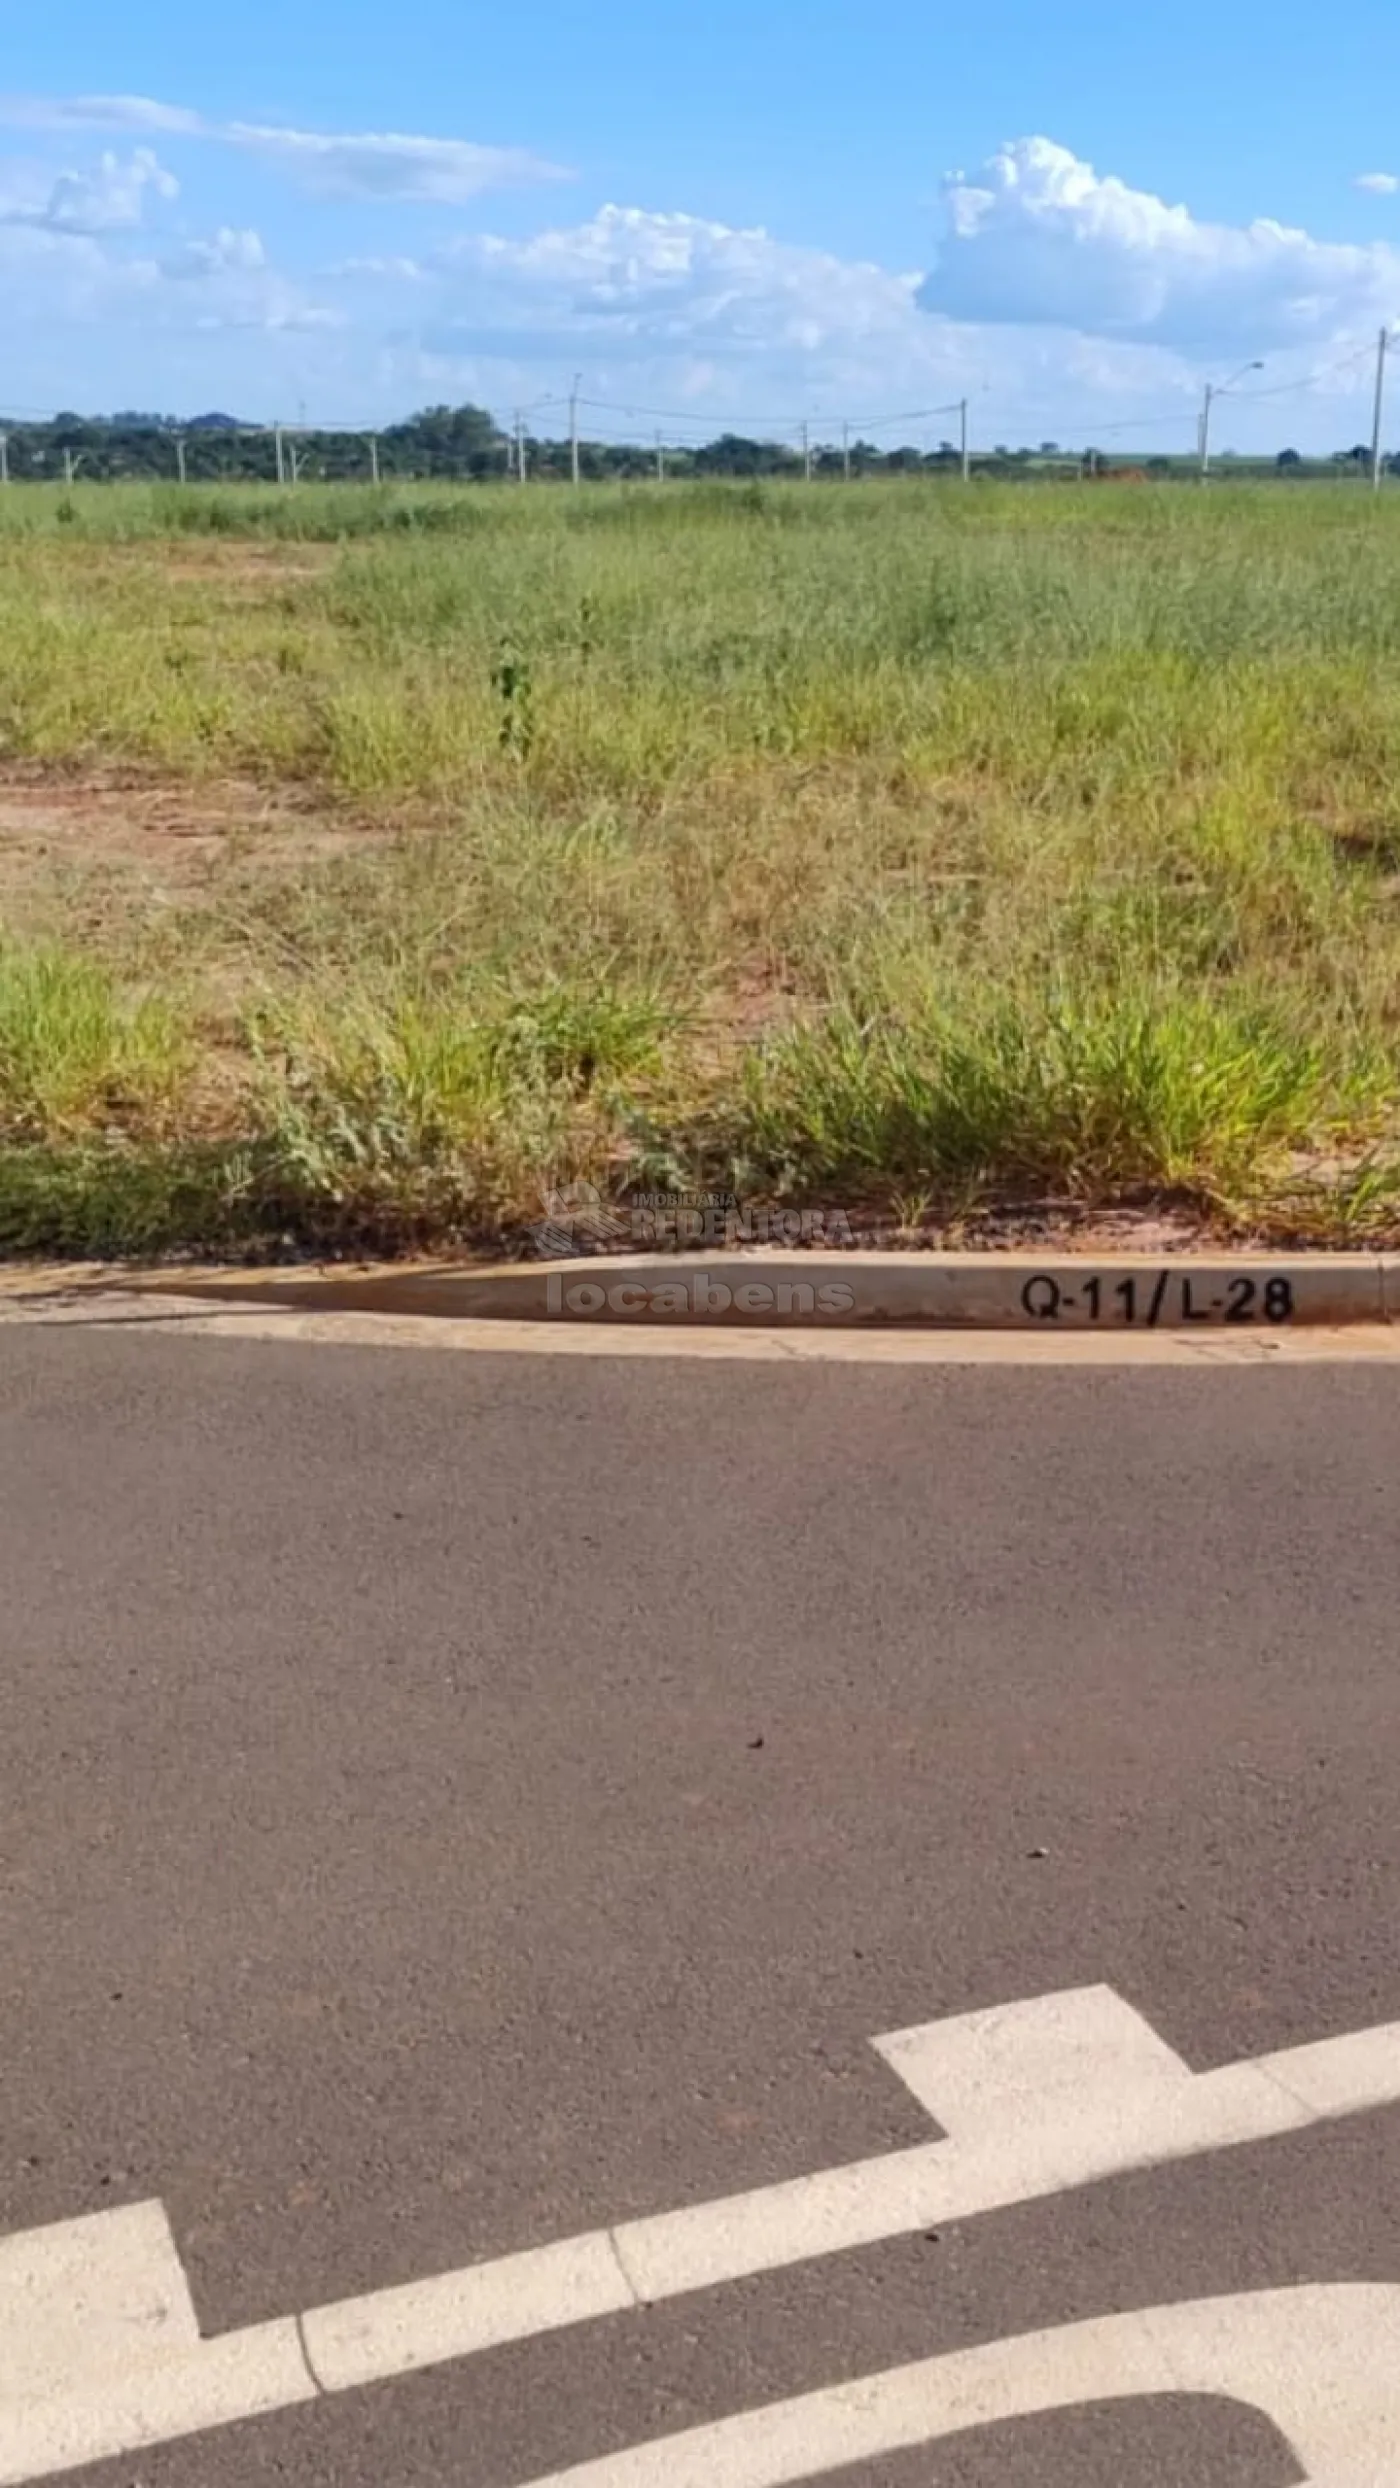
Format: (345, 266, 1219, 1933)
(512, 2286, 1400, 2488)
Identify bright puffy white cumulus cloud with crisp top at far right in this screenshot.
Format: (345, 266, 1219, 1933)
(920, 137, 1400, 353)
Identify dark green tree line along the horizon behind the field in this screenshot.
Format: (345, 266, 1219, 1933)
(0, 406, 1400, 483)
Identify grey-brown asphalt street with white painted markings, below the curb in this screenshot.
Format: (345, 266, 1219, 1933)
(0, 1326, 1400, 2488)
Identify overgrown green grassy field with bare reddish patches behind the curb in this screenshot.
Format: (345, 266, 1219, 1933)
(0, 480, 1400, 1251)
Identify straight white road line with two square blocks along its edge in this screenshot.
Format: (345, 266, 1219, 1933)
(0, 1988, 1400, 2488)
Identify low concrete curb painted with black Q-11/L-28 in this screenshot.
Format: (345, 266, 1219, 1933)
(95, 1251, 1400, 1334)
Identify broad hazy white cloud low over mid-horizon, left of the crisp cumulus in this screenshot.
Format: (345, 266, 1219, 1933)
(370, 207, 1199, 457)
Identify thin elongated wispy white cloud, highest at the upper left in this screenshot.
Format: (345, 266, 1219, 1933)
(0, 95, 564, 207)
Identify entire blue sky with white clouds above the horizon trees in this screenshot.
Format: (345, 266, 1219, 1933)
(0, 0, 1400, 450)
